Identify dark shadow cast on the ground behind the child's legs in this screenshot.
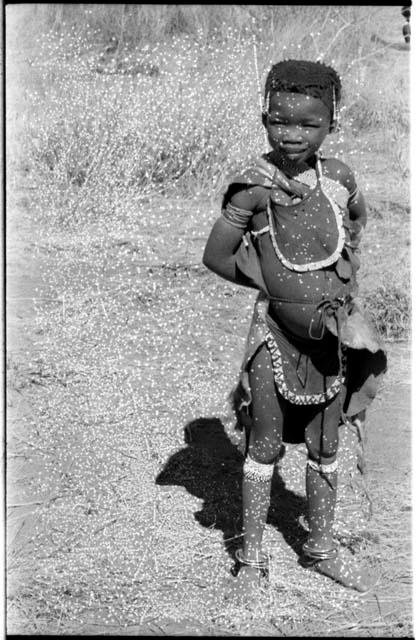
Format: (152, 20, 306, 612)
(156, 418, 306, 557)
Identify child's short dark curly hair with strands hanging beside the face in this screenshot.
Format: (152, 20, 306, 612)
(263, 60, 341, 126)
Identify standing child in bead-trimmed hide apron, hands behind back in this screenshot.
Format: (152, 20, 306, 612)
(203, 60, 386, 591)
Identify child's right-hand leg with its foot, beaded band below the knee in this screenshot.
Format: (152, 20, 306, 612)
(304, 398, 368, 591)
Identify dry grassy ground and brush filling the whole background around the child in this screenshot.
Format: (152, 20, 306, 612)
(7, 5, 411, 636)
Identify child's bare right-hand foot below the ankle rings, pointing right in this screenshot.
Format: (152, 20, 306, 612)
(301, 552, 374, 593)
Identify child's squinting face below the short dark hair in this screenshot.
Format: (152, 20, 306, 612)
(263, 91, 331, 165)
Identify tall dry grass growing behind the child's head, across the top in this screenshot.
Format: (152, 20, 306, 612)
(10, 5, 409, 202)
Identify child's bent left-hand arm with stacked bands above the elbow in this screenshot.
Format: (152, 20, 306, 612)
(202, 188, 258, 287)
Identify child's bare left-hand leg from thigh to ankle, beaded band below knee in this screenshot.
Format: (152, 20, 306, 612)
(237, 347, 283, 576)
